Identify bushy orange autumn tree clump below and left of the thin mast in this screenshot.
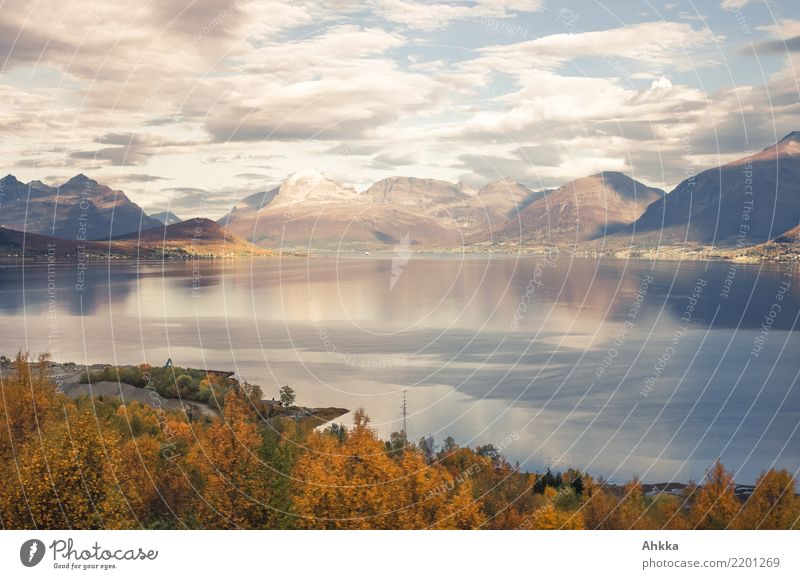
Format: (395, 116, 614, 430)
(293, 409, 483, 529)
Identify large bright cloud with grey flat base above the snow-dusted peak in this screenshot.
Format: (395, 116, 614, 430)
(203, 25, 442, 142)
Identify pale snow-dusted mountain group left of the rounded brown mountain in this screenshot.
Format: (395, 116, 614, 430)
(219, 173, 537, 249)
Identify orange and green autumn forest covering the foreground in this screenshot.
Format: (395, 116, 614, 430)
(0, 354, 800, 529)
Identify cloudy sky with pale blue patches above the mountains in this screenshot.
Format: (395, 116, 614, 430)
(0, 0, 800, 218)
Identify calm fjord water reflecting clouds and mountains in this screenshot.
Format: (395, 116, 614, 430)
(0, 255, 800, 482)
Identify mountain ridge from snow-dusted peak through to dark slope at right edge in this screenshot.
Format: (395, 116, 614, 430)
(221, 132, 800, 251)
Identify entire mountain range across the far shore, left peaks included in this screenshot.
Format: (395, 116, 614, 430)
(0, 132, 800, 258)
